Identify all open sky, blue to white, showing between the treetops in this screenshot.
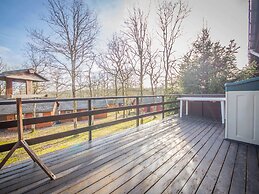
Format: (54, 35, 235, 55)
(0, 0, 248, 68)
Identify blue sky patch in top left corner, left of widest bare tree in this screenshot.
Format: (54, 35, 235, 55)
(0, 0, 46, 66)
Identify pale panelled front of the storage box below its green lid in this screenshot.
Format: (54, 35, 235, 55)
(226, 91, 259, 145)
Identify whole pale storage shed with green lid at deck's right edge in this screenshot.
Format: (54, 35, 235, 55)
(225, 77, 259, 145)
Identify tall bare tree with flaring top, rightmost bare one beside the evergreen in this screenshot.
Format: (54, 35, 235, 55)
(158, 0, 190, 92)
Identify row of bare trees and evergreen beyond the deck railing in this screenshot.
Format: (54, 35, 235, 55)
(0, 0, 257, 97)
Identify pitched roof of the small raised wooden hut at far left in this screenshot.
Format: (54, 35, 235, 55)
(0, 69, 48, 82)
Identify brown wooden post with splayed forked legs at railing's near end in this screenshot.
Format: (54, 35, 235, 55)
(0, 98, 56, 180)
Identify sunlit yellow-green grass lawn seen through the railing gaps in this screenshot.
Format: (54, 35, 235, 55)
(0, 113, 161, 165)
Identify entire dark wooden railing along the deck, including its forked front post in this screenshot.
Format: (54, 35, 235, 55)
(0, 95, 179, 180)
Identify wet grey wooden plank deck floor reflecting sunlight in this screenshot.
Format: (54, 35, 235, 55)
(0, 118, 259, 194)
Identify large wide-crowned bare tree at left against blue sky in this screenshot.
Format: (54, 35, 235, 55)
(30, 0, 99, 128)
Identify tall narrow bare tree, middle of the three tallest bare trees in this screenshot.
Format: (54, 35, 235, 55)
(124, 8, 148, 96)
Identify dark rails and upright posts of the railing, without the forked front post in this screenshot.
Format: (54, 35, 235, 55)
(0, 95, 179, 152)
